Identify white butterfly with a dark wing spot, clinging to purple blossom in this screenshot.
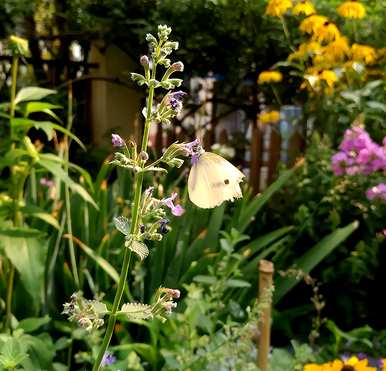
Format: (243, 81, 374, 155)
(188, 152, 244, 209)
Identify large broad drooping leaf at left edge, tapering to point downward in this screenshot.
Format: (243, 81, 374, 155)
(0, 234, 48, 308)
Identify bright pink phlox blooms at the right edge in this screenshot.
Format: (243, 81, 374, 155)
(331, 126, 386, 201)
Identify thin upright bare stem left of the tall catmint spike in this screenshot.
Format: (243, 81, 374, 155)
(64, 81, 80, 289)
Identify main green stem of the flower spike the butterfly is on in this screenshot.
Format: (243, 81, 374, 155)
(92, 63, 157, 371)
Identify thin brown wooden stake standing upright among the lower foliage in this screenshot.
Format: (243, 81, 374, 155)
(257, 260, 274, 371)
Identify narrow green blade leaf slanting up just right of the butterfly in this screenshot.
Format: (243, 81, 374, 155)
(236, 166, 298, 233)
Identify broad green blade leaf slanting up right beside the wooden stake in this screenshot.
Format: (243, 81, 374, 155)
(274, 221, 359, 304)
